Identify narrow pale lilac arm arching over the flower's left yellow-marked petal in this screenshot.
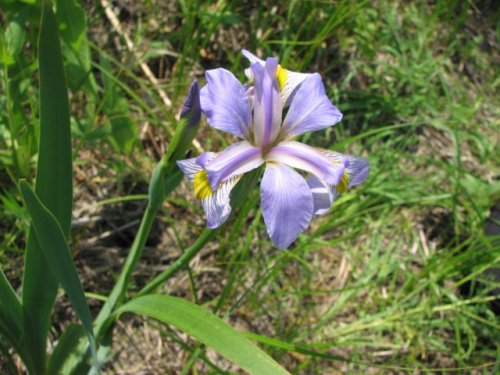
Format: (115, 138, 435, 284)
(205, 141, 264, 190)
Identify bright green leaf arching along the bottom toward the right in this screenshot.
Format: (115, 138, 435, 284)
(117, 295, 289, 375)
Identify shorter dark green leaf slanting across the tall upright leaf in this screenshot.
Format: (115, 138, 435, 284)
(19, 180, 97, 362)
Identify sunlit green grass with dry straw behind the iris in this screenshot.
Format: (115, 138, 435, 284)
(0, 0, 500, 374)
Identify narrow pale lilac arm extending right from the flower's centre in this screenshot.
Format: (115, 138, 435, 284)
(265, 141, 345, 185)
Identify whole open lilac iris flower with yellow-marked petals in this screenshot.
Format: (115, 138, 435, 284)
(177, 51, 368, 249)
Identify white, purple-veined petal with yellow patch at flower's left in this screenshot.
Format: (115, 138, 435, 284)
(177, 152, 240, 229)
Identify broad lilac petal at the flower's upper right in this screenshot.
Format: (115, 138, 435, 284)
(283, 73, 342, 137)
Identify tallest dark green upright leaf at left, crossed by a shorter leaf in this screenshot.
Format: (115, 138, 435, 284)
(22, 1, 73, 373)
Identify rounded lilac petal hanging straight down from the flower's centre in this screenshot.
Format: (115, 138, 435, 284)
(260, 163, 314, 249)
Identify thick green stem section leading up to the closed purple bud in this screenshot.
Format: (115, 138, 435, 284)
(94, 204, 158, 337)
